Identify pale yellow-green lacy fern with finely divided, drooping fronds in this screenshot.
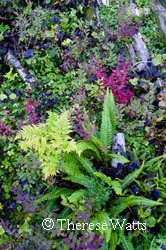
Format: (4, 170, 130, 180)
(16, 111, 81, 179)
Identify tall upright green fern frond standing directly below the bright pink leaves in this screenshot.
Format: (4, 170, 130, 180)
(100, 89, 116, 148)
